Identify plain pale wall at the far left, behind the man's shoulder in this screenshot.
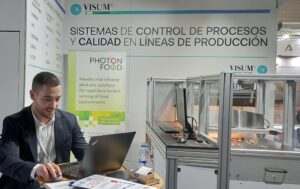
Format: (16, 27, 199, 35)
(0, 0, 26, 133)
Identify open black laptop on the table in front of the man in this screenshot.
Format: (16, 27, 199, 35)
(59, 132, 136, 179)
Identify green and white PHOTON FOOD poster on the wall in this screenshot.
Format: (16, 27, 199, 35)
(67, 52, 126, 127)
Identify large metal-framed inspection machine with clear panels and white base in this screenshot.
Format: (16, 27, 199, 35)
(146, 73, 300, 189)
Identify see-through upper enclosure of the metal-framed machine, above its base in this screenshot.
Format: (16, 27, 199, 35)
(147, 73, 300, 151)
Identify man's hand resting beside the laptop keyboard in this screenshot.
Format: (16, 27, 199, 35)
(35, 162, 62, 182)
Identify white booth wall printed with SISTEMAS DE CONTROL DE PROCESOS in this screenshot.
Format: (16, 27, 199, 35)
(64, 0, 277, 165)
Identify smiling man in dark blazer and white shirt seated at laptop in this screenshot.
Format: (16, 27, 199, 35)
(0, 72, 87, 189)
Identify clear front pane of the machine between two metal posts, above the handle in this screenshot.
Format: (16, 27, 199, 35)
(231, 79, 285, 150)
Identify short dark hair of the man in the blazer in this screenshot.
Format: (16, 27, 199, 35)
(32, 72, 60, 91)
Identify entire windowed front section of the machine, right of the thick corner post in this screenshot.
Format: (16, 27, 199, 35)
(231, 76, 299, 151)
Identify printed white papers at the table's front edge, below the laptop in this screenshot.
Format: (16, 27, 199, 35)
(72, 175, 155, 189)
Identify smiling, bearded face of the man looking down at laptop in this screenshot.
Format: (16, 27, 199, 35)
(30, 85, 61, 121)
